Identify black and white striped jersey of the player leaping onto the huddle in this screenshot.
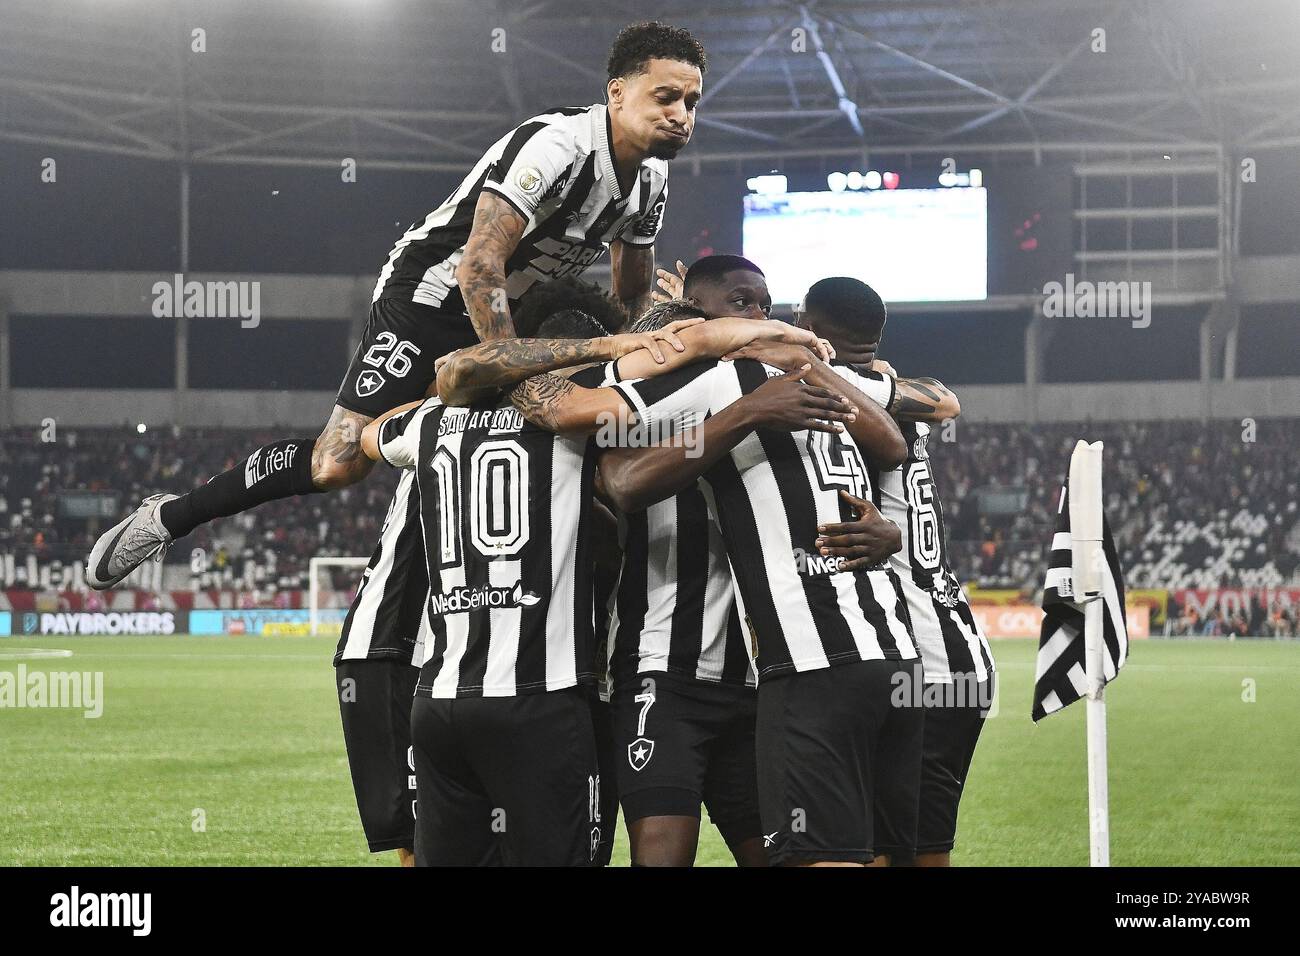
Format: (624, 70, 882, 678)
(373, 103, 668, 313)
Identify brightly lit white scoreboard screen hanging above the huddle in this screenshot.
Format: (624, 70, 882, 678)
(744, 187, 988, 304)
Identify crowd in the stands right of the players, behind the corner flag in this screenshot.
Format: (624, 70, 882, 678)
(931, 421, 1300, 591)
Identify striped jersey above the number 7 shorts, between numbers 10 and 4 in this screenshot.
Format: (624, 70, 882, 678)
(608, 488, 755, 692)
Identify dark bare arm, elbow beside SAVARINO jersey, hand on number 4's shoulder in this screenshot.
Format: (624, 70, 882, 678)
(599, 364, 855, 512)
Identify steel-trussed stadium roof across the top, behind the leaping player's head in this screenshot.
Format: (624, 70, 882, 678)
(0, 0, 1300, 170)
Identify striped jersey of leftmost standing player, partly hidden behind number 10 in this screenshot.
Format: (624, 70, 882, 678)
(334, 471, 429, 666)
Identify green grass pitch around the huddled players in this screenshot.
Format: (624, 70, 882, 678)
(0, 636, 1300, 866)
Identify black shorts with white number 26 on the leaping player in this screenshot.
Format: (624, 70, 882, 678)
(334, 299, 478, 419)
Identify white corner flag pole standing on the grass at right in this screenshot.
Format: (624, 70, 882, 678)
(1070, 441, 1110, 866)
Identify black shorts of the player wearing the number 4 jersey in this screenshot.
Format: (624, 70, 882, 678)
(758, 661, 924, 866)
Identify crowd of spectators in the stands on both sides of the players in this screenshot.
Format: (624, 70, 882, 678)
(0, 420, 1300, 606)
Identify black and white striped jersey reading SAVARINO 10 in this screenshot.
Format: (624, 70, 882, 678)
(380, 367, 605, 697)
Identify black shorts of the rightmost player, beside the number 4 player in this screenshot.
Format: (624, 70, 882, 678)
(917, 674, 997, 853)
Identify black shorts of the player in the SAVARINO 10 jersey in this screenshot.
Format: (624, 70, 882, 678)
(411, 687, 602, 866)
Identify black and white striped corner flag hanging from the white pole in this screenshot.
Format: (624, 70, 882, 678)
(1034, 481, 1128, 721)
